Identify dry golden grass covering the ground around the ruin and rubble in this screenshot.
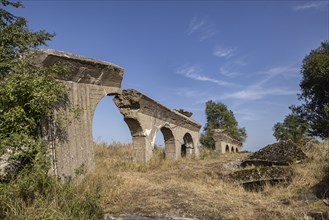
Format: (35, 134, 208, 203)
(83, 142, 329, 220)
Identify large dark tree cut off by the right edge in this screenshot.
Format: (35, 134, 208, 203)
(292, 41, 329, 138)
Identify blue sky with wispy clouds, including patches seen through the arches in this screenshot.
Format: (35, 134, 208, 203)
(12, 0, 329, 151)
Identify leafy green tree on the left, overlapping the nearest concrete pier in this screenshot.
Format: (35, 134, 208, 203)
(0, 0, 68, 181)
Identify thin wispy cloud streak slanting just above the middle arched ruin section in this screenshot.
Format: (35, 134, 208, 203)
(176, 65, 234, 87)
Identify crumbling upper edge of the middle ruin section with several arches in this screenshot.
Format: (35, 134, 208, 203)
(115, 89, 201, 131)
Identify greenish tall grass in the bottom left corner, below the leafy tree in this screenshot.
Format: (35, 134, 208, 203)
(0, 155, 103, 220)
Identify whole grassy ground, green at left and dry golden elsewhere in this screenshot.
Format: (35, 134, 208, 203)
(0, 142, 329, 220)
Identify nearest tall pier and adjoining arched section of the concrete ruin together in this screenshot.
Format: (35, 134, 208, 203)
(34, 50, 201, 178)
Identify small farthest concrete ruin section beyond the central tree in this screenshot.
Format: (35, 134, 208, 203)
(213, 129, 242, 154)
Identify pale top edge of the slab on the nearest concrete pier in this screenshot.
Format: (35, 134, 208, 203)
(34, 49, 124, 72)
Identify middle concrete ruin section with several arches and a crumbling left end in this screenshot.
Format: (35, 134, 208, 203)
(114, 89, 201, 162)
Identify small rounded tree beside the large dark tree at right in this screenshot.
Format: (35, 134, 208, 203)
(273, 113, 311, 146)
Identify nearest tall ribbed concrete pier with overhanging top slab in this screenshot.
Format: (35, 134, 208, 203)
(34, 50, 123, 178)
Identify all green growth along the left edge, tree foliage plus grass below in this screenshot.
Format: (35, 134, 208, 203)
(0, 0, 103, 219)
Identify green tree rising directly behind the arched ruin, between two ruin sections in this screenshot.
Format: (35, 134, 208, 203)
(200, 100, 247, 149)
